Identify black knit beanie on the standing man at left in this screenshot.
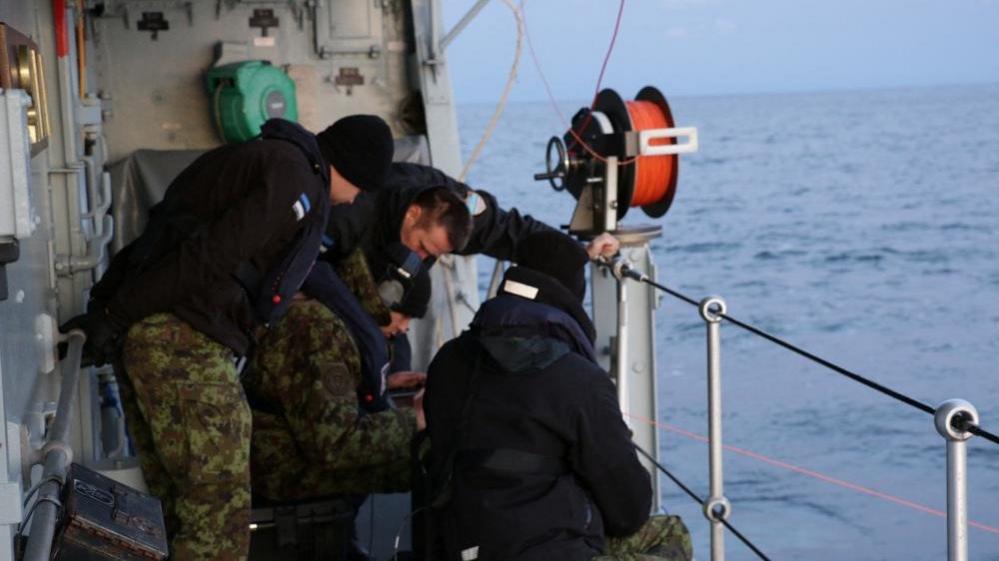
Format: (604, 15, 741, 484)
(316, 115, 395, 191)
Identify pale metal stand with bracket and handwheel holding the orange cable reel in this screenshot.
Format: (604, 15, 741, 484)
(534, 99, 697, 511)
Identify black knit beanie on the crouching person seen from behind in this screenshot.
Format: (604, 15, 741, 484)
(514, 230, 590, 302)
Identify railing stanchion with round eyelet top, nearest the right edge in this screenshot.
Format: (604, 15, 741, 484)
(933, 399, 978, 561)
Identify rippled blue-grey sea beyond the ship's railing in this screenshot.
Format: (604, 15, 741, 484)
(458, 86, 999, 561)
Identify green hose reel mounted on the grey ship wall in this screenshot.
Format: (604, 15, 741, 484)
(205, 60, 298, 143)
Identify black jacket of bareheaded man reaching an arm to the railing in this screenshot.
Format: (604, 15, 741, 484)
(326, 162, 552, 260)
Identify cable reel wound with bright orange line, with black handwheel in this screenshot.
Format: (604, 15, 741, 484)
(534, 86, 697, 234)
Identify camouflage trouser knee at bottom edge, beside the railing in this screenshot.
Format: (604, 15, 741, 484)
(593, 515, 693, 561)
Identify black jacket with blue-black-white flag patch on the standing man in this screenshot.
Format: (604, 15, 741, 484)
(91, 121, 329, 354)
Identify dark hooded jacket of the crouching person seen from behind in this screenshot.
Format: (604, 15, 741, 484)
(424, 274, 652, 561)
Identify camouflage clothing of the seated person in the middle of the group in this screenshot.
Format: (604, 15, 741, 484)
(243, 300, 416, 500)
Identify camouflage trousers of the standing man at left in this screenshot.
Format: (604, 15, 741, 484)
(116, 314, 251, 561)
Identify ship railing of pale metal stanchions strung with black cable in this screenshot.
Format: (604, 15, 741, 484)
(598, 258, 999, 561)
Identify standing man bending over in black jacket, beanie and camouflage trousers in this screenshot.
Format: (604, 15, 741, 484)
(67, 115, 392, 561)
